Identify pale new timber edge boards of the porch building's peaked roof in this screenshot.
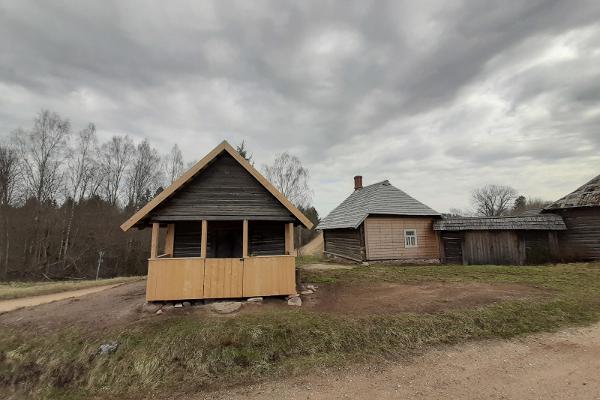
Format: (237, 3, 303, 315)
(121, 140, 313, 231)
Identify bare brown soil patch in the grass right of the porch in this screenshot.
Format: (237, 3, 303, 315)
(303, 282, 547, 314)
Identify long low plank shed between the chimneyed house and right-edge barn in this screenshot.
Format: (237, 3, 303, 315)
(433, 213, 567, 265)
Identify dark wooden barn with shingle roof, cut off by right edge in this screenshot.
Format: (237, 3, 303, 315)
(543, 175, 600, 261)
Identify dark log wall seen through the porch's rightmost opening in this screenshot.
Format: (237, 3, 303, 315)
(248, 221, 285, 256)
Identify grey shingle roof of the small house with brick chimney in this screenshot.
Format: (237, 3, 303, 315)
(317, 180, 440, 229)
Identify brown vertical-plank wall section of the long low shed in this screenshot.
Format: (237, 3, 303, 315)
(463, 231, 526, 265)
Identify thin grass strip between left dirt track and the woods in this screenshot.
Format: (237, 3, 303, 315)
(0, 276, 142, 300)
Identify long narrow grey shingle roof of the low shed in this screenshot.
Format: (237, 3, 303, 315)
(433, 214, 567, 231)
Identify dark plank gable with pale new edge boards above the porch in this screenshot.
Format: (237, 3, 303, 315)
(121, 141, 313, 231)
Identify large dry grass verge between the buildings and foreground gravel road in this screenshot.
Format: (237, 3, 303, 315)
(0, 263, 600, 399)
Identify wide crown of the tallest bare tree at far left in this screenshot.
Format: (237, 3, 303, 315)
(14, 110, 71, 203)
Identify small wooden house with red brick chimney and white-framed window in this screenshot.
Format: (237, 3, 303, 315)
(317, 176, 440, 262)
